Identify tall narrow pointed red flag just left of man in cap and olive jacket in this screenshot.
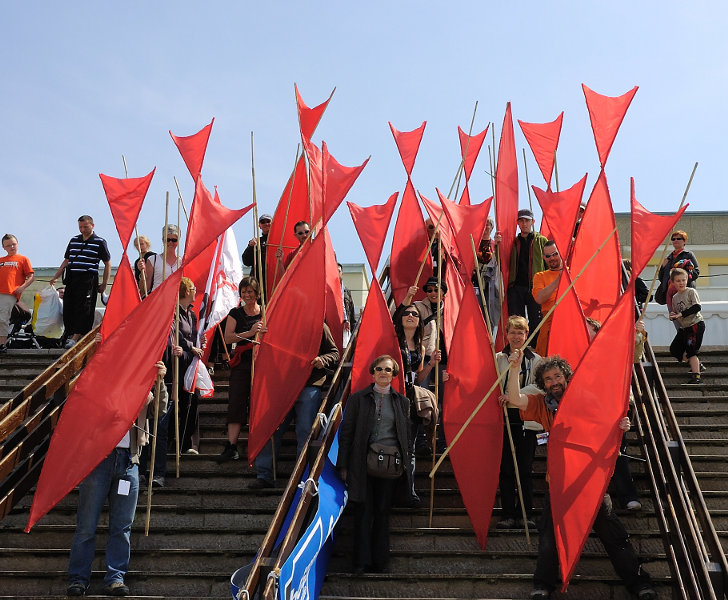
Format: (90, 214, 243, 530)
(495, 102, 518, 304)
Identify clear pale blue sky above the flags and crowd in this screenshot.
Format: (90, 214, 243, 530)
(0, 0, 728, 266)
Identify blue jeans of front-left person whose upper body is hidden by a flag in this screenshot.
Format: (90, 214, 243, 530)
(68, 448, 139, 586)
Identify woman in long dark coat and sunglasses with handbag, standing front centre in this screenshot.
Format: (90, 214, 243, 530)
(336, 354, 411, 574)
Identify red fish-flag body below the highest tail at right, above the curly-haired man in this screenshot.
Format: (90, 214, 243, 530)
(571, 171, 622, 323)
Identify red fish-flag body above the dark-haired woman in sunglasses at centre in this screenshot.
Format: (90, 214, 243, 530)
(389, 179, 432, 304)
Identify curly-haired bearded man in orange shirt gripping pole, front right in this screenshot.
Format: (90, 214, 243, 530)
(500, 349, 657, 600)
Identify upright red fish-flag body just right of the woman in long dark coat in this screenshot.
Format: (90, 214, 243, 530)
(443, 286, 503, 549)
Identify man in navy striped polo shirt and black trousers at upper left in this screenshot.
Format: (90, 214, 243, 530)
(50, 215, 111, 348)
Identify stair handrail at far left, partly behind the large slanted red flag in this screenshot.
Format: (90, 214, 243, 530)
(0, 325, 101, 520)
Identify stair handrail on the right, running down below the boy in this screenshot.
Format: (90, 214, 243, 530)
(632, 343, 728, 600)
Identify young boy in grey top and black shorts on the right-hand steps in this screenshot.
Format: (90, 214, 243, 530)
(670, 268, 705, 384)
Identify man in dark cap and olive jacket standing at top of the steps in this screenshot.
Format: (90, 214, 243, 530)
(507, 208, 548, 345)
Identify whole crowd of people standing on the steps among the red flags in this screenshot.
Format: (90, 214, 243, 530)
(0, 209, 705, 600)
